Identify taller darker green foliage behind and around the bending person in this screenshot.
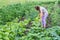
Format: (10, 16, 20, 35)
(0, 2, 60, 25)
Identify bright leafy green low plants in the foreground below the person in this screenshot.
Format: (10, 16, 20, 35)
(0, 22, 60, 40)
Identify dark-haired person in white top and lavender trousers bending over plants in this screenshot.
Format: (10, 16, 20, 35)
(35, 6, 48, 28)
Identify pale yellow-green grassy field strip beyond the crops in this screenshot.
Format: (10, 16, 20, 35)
(0, 0, 56, 8)
